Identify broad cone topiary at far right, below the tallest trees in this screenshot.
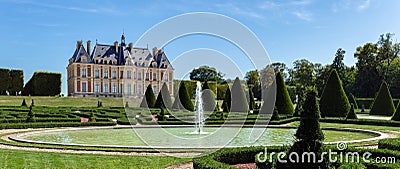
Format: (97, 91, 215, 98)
(370, 81, 395, 116)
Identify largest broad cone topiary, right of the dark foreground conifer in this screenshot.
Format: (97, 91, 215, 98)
(320, 69, 350, 117)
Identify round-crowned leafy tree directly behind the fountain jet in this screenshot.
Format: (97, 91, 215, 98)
(190, 66, 224, 83)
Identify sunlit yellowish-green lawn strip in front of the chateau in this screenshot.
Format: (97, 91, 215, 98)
(0, 96, 126, 107)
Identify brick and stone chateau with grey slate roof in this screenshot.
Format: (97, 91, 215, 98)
(67, 35, 174, 97)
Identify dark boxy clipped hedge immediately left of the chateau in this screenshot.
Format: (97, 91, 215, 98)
(22, 72, 61, 96)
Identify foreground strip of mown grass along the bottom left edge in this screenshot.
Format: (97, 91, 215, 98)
(0, 149, 191, 168)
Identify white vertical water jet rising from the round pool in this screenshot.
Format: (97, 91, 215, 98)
(189, 81, 208, 134)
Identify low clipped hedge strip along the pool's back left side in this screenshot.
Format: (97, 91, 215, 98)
(0, 122, 116, 129)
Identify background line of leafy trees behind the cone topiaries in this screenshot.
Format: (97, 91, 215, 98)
(190, 33, 400, 99)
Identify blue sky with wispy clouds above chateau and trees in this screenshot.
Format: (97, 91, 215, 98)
(0, 0, 400, 93)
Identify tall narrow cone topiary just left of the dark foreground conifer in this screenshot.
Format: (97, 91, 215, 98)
(275, 72, 294, 115)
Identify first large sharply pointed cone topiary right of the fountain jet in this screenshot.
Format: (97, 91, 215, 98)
(230, 77, 249, 113)
